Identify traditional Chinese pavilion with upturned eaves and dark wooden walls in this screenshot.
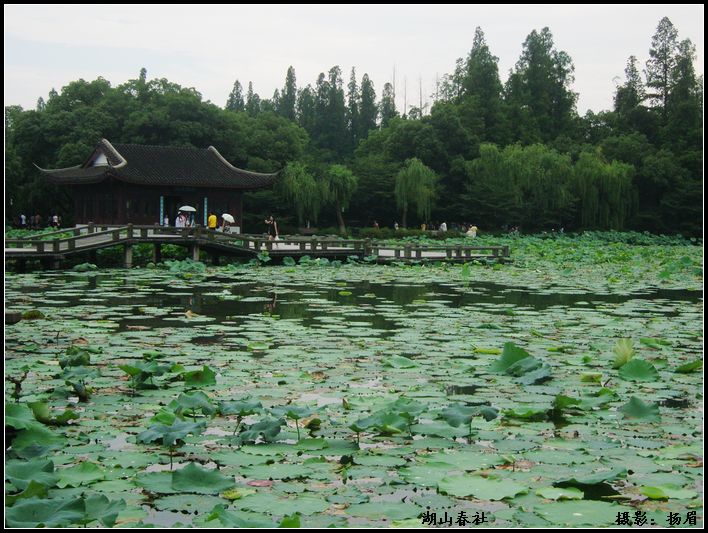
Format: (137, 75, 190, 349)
(38, 139, 278, 231)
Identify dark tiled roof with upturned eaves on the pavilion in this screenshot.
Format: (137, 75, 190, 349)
(40, 139, 278, 189)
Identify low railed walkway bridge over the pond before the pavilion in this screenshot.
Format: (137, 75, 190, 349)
(5, 224, 509, 268)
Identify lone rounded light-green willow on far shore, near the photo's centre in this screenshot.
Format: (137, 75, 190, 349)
(395, 157, 438, 228)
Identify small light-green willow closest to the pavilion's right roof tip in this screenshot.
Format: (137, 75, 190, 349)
(277, 162, 325, 227)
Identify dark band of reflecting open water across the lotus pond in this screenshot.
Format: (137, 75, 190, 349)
(8, 274, 702, 334)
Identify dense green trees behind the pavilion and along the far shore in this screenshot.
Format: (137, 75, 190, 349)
(5, 18, 703, 235)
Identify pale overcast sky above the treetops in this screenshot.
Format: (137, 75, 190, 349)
(4, 4, 703, 114)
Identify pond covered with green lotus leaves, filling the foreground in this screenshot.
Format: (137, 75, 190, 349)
(5, 235, 703, 527)
